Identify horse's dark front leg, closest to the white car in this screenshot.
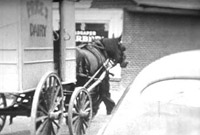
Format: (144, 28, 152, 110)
(100, 74, 115, 115)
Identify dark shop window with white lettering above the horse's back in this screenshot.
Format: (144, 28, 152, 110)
(76, 23, 108, 45)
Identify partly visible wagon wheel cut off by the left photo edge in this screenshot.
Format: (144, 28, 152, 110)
(0, 94, 7, 132)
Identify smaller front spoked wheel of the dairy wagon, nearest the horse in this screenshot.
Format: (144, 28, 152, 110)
(68, 87, 92, 135)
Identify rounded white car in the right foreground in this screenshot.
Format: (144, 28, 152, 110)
(99, 50, 200, 135)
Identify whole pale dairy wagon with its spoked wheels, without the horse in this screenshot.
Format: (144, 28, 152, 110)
(0, 0, 101, 135)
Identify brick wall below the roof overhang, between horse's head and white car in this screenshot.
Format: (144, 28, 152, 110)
(121, 11, 200, 88)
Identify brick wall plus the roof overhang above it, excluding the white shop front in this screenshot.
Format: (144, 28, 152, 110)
(92, 0, 200, 87)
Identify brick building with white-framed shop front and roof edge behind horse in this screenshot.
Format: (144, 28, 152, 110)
(54, 0, 200, 88)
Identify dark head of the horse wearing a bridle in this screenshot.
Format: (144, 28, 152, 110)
(101, 36, 128, 68)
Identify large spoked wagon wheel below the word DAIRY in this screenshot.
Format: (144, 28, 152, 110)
(31, 73, 64, 135)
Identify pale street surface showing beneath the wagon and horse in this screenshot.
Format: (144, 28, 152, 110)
(0, 84, 123, 135)
